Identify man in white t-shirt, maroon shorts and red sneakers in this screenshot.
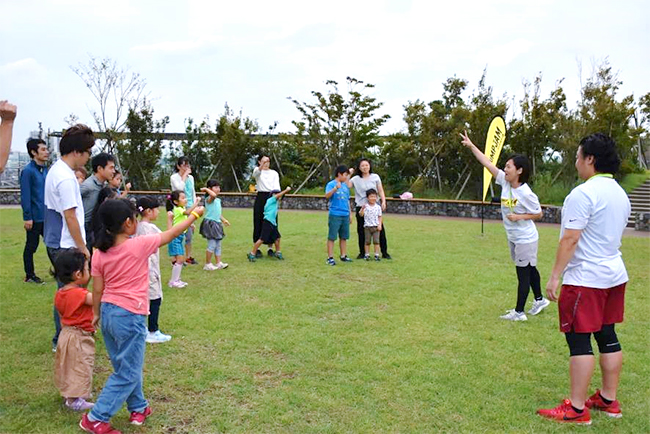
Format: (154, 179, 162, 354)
(538, 134, 631, 424)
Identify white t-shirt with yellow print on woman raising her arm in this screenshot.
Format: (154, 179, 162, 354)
(496, 170, 542, 244)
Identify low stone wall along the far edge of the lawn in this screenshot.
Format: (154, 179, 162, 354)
(0, 190, 561, 223)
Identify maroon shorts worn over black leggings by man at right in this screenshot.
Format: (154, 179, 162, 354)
(558, 283, 626, 333)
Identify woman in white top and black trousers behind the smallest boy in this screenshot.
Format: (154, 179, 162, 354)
(350, 158, 392, 259)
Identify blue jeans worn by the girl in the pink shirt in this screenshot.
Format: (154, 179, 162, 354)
(89, 303, 149, 422)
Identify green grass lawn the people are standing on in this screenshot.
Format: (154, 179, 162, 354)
(0, 209, 650, 434)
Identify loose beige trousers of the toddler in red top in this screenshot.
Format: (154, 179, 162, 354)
(54, 326, 95, 398)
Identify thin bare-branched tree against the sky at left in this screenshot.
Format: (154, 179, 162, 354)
(69, 56, 147, 153)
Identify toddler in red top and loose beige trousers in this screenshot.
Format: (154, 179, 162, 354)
(54, 249, 95, 411)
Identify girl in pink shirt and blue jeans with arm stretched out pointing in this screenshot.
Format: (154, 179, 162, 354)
(79, 199, 203, 434)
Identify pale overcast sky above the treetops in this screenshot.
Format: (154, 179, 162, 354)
(0, 0, 650, 150)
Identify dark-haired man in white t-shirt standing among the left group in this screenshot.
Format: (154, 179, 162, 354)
(43, 124, 95, 350)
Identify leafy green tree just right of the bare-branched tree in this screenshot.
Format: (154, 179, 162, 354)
(116, 101, 169, 190)
